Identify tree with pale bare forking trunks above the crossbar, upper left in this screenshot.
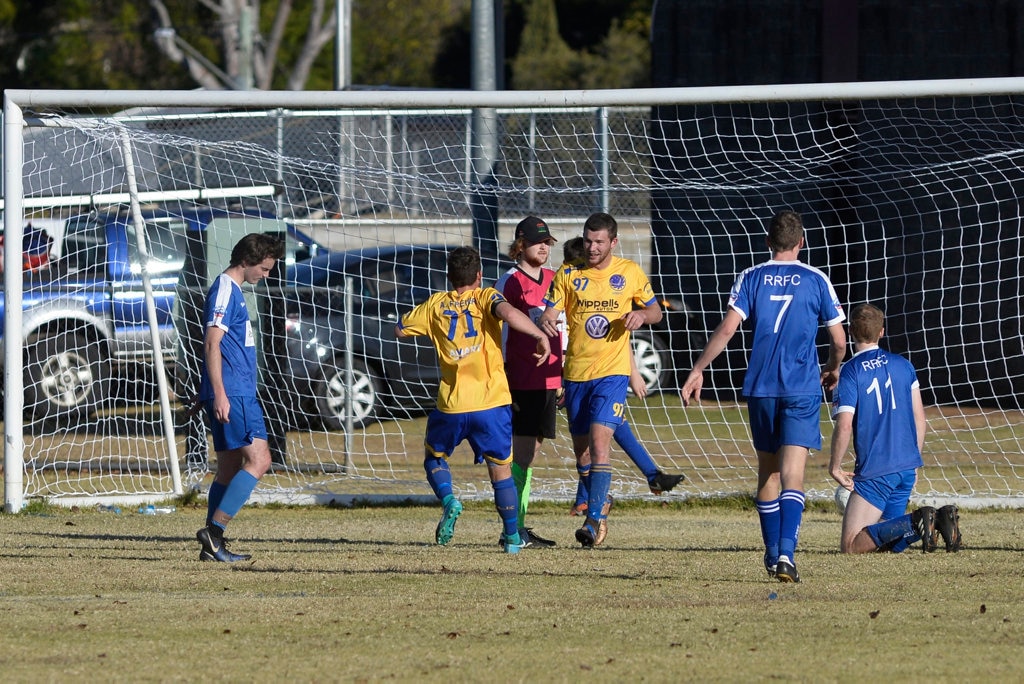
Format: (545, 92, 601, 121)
(150, 0, 337, 90)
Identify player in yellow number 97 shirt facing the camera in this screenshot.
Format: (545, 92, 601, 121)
(540, 213, 663, 548)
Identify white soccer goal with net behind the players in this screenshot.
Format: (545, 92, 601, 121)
(3, 79, 1024, 510)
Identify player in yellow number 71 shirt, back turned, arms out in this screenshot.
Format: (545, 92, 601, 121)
(395, 242, 551, 553)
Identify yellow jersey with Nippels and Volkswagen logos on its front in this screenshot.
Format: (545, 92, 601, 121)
(545, 257, 655, 382)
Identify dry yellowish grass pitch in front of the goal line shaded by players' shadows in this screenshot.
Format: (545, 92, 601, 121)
(0, 501, 1024, 682)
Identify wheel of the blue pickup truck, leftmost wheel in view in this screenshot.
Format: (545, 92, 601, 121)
(24, 333, 106, 425)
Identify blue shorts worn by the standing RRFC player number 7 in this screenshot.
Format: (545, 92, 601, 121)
(746, 394, 821, 454)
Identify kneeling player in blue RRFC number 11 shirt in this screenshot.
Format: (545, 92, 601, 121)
(828, 304, 961, 553)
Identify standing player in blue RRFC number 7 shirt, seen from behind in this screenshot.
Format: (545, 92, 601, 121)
(681, 210, 846, 582)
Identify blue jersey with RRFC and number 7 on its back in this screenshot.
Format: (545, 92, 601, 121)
(729, 259, 846, 397)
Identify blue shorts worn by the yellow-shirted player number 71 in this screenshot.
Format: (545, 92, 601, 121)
(424, 407, 512, 466)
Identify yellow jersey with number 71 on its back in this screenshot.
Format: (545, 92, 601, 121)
(398, 288, 512, 414)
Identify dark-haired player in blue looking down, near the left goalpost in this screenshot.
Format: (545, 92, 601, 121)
(196, 233, 285, 563)
